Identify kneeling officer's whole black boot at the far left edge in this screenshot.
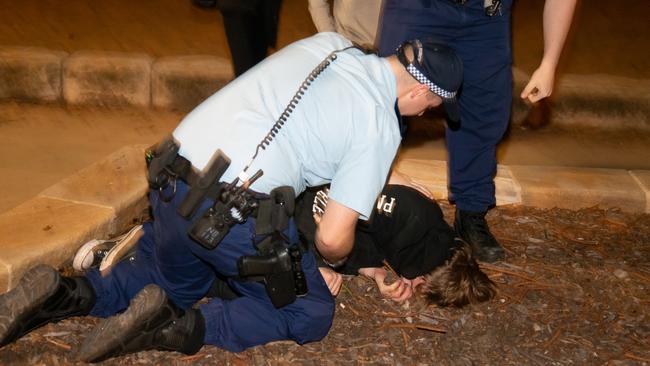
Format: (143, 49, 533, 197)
(0, 265, 95, 347)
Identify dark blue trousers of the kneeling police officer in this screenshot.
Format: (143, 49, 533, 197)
(86, 181, 334, 352)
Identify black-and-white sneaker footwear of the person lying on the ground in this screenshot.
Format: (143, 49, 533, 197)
(72, 225, 143, 272)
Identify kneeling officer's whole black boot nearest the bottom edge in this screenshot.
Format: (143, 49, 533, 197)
(78, 285, 205, 362)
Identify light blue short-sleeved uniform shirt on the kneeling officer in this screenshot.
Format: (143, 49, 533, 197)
(173, 33, 401, 219)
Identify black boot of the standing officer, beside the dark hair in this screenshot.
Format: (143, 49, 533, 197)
(454, 209, 505, 262)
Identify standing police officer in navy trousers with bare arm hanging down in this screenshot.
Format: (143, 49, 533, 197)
(379, 0, 576, 262)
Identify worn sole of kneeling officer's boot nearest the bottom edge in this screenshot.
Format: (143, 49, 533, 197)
(78, 285, 167, 362)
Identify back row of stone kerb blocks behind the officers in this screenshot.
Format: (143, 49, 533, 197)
(0, 47, 650, 130)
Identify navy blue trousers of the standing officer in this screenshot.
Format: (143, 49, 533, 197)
(379, 0, 512, 211)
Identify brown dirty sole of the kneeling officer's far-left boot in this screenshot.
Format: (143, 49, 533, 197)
(0, 264, 61, 347)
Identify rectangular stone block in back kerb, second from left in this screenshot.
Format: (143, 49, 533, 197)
(63, 51, 152, 107)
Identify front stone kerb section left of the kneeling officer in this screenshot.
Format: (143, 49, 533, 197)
(0, 145, 149, 292)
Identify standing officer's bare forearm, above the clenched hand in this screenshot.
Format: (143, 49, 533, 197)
(541, 0, 577, 70)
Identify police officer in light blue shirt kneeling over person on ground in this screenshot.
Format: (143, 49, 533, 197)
(0, 33, 462, 362)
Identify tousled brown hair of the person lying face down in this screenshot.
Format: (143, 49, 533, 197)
(421, 244, 496, 307)
